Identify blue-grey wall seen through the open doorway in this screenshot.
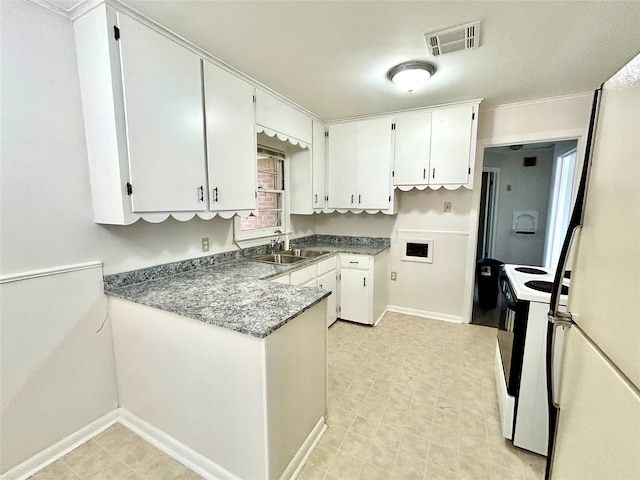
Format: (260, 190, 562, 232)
(484, 148, 554, 266)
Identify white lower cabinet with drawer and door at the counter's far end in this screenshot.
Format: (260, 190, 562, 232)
(338, 251, 388, 325)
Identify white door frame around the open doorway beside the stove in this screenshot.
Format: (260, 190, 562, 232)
(462, 129, 588, 323)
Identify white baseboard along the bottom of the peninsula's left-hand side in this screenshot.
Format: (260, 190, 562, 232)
(118, 408, 240, 480)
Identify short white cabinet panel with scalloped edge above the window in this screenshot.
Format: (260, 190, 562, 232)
(256, 89, 313, 146)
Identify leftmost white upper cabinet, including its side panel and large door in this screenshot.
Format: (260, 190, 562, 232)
(74, 5, 207, 224)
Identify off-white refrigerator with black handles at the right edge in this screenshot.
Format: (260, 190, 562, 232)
(546, 55, 640, 480)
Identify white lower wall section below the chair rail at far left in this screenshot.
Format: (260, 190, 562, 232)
(0, 264, 118, 474)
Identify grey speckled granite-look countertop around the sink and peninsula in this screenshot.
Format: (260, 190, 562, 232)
(105, 236, 389, 338)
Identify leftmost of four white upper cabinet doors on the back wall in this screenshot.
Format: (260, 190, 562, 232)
(327, 122, 358, 208)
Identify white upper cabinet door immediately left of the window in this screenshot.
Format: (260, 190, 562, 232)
(204, 60, 256, 211)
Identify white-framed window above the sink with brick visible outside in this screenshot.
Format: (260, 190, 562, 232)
(235, 145, 287, 244)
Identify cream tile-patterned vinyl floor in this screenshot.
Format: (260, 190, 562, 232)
(26, 313, 545, 480)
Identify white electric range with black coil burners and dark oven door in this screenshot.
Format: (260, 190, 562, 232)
(495, 264, 569, 455)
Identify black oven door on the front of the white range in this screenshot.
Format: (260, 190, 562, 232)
(498, 275, 529, 397)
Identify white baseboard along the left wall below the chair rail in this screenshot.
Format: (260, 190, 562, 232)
(0, 410, 119, 480)
